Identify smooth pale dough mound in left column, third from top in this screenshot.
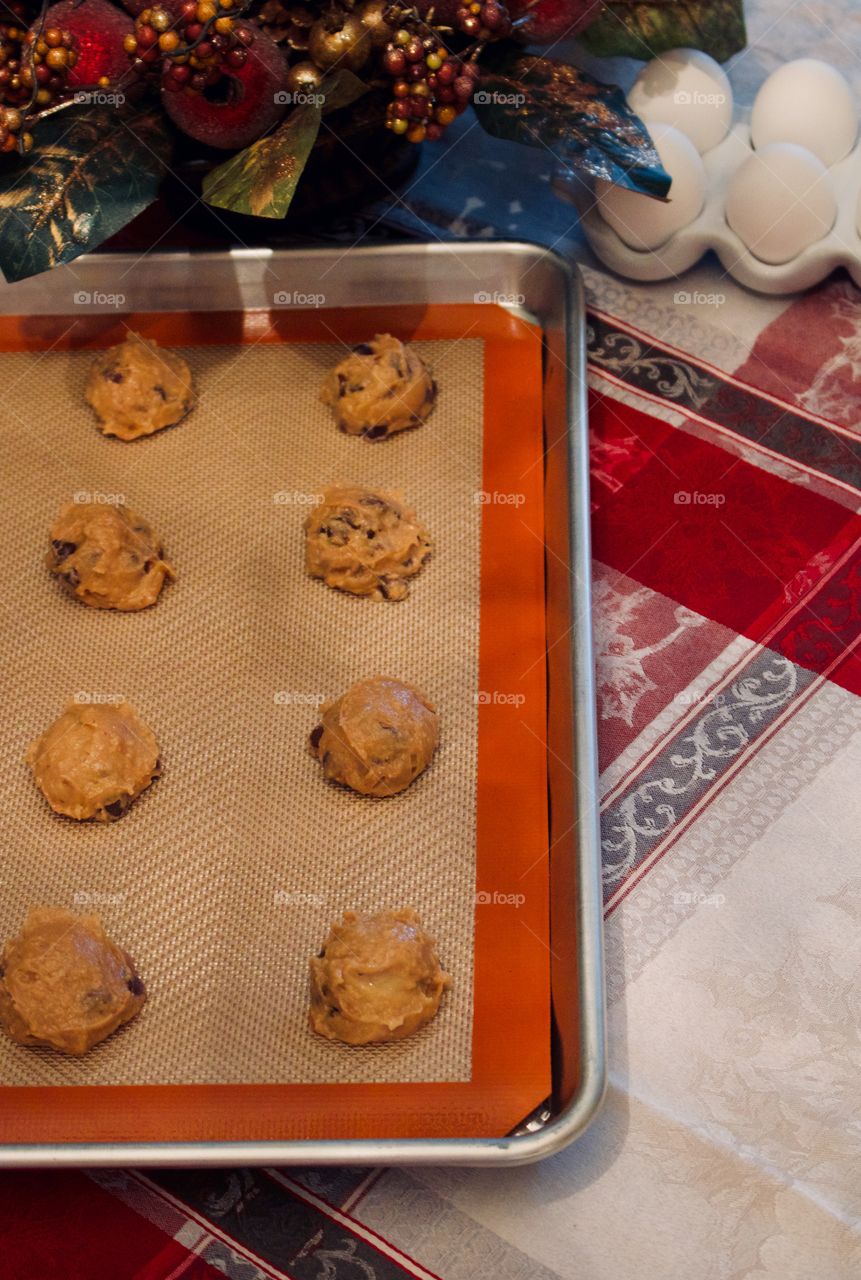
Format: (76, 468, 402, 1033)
(24, 703, 161, 822)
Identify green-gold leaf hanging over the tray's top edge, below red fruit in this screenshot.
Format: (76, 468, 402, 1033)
(203, 70, 367, 218)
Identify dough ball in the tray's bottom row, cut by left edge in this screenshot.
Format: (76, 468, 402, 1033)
(0, 906, 146, 1057)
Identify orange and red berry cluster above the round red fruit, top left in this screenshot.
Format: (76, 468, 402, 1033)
(124, 0, 253, 93)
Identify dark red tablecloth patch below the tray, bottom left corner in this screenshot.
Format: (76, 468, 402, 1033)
(0, 1170, 223, 1280)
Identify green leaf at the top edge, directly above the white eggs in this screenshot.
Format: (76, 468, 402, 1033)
(580, 0, 747, 63)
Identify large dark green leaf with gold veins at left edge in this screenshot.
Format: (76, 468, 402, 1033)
(0, 104, 170, 280)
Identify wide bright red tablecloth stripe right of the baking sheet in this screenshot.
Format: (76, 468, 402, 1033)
(591, 393, 861, 692)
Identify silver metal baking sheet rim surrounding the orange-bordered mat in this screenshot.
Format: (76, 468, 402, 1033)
(0, 243, 605, 1166)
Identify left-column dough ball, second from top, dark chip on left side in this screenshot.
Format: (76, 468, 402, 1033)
(47, 503, 177, 611)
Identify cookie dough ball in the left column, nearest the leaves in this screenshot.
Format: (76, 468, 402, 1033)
(86, 333, 194, 440)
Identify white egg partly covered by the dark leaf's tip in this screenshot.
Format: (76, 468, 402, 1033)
(595, 124, 706, 250)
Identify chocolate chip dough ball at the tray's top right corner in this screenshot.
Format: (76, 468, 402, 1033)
(320, 333, 436, 440)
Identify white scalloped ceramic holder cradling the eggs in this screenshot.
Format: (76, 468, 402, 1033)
(573, 123, 861, 293)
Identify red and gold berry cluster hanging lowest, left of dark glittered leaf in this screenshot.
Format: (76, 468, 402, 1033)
(383, 27, 478, 142)
